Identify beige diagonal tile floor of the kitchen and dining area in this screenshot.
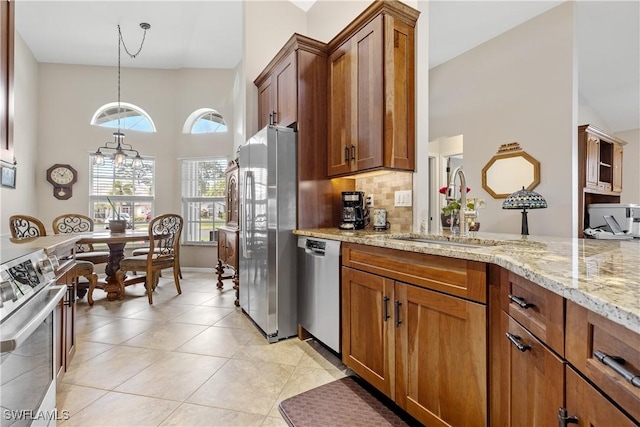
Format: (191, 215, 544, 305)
(57, 271, 347, 427)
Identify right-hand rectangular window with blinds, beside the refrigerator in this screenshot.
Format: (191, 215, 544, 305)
(182, 157, 227, 245)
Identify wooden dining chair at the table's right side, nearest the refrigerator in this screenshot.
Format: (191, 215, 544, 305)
(116, 214, 184, 304)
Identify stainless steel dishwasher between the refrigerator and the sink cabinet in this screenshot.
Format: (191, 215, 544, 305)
(298, 236, 340, 353)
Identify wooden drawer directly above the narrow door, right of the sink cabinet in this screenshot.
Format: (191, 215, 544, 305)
(500, 272, 564, 356)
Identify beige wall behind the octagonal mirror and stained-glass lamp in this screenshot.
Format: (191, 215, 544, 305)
(424, 3, 577, 236)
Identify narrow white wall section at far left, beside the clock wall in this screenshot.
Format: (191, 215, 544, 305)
(0, 34, 38, 237)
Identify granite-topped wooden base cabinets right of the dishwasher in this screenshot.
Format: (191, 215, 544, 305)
(294, 229, 640, 426)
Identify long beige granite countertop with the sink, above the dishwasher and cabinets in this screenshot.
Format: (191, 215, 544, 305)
(294, 228, 640, 333)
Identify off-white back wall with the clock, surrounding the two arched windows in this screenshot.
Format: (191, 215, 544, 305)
(22, 63, 234, 267)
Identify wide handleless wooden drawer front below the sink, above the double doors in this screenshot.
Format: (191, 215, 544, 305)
(342, 243, 487, 303)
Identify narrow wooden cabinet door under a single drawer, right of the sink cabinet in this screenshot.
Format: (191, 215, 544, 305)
(503, 313, 564, 427)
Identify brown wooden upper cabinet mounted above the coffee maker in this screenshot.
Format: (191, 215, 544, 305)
(327, 1, 419, 176)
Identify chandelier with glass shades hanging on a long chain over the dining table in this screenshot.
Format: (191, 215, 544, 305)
(93, 22, 151, 170)
